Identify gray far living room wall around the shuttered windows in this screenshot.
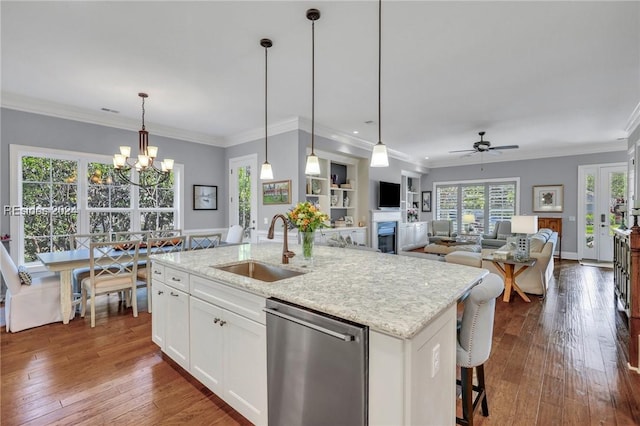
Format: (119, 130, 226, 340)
(422, 151, 627, 253)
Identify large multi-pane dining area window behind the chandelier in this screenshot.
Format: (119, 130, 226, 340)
(10, 145, 183, 264)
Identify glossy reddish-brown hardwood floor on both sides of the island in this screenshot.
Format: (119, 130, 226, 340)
(0, 260, 640, 426)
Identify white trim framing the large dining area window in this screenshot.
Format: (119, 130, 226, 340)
(9, 144, 185, 269)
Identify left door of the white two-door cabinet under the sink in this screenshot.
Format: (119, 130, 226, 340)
(190, 297, 224, 395)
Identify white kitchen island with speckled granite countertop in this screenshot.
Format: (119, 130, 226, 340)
(152, 244, 488, 425)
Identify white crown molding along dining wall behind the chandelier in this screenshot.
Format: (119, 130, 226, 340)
(0, 91, 222, 146)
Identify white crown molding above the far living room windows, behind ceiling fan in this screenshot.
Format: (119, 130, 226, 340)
(429, 140, 627, 169)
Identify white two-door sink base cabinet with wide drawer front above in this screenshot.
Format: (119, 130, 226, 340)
(190, 275, 268, 424)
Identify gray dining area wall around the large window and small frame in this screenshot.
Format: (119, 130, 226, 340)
(0, 108, 227, 235)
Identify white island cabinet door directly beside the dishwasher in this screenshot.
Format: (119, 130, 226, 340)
(222, 310, 268, 425)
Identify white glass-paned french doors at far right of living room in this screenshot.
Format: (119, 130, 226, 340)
(578, 163, 629, 262)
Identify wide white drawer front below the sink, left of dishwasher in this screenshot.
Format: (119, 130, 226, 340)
(190, 275, 266, 324)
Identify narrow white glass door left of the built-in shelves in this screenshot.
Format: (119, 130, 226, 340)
(229, 154, 258, 243)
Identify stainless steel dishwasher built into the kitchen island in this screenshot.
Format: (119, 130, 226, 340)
(265, 298, 369, 426)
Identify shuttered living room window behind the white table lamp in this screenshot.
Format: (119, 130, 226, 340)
(434, 178, 520, 234)
